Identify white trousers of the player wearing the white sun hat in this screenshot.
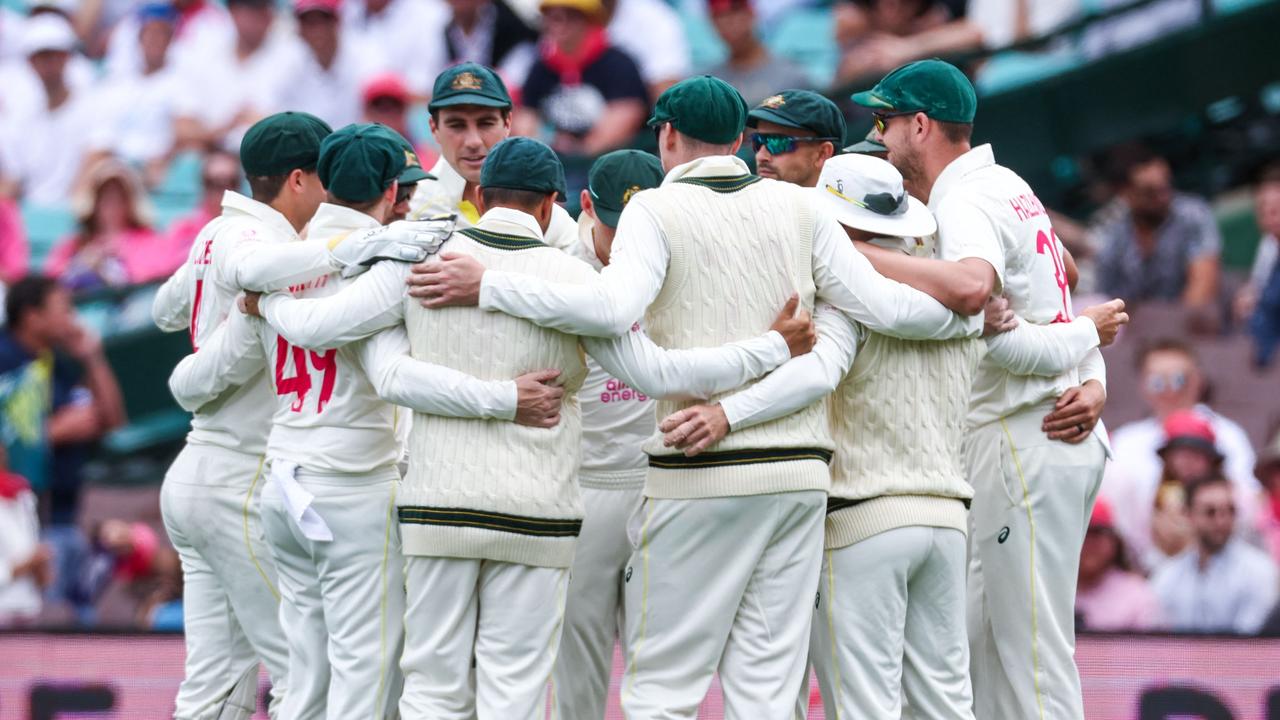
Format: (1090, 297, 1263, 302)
(803, 527, 974, 720)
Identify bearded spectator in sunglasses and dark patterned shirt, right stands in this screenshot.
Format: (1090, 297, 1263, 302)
(1093, 152, 1222, 307)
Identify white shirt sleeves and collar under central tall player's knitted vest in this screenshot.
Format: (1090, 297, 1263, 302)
(480, 156, 982, 340)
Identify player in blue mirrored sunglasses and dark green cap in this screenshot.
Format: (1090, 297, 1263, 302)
(746, 90, 845, 187)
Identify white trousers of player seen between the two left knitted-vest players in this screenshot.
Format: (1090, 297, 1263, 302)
(552, 484, 644, 720)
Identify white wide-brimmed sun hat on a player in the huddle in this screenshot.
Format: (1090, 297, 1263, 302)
(813, 155, 938, 237)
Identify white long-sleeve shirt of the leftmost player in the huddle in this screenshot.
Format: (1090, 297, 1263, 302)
(151, 191, 309, 455)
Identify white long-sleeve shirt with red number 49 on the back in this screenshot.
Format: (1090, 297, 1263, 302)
(169, 204, 516, 473)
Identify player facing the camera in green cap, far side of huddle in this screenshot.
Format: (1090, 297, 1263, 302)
(410, 63, 577, 250)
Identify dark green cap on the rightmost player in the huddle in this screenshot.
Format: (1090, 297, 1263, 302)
(852, 58, 978, 123)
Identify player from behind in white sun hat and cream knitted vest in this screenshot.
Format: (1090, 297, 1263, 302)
(660, 155, 1117, 720)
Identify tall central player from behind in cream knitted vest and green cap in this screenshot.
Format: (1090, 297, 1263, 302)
(411, 76, 975, 719)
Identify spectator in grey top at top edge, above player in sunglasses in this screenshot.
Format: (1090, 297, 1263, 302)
(707, 0, 813, 106)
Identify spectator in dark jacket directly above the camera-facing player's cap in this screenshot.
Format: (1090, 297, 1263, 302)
(439, 0, 538, 87)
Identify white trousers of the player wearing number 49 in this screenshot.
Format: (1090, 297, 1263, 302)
(262, 468, 404, 720)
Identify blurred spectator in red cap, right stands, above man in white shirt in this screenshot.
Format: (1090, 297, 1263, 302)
(1143, 410, 1224, 568)
